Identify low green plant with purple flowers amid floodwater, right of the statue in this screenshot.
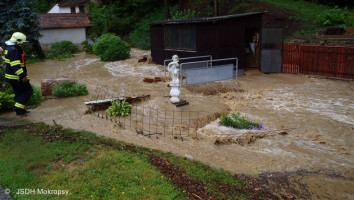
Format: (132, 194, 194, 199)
(220, 112, 262, 129)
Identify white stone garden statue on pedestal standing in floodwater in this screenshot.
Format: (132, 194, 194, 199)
(167, 55, 181, 103)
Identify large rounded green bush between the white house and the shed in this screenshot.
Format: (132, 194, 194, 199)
(93, 33, 130, 61)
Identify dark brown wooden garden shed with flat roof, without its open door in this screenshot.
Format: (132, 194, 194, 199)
(150, 12, 263, 68)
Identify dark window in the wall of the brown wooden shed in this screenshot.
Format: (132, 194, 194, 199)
(165, 25, 196, 51)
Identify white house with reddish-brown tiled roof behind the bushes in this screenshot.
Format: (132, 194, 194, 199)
(39, 0, 92, 49)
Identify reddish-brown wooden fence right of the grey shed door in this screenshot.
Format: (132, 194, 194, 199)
(282, 43, 354, 79)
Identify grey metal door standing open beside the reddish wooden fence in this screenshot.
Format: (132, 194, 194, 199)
(260, 28, 283, 73)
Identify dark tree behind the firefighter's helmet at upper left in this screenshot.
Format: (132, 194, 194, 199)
(0, 0, 45, 58)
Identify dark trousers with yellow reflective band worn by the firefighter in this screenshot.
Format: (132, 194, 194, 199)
(10, 81, 33, 115)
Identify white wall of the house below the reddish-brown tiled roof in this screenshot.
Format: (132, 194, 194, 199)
(39, 28, 86, 44)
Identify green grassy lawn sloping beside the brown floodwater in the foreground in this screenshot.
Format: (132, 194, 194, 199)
(0, 124, 248, 199)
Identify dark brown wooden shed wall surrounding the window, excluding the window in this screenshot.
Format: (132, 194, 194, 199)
(151, 15, 262, 68)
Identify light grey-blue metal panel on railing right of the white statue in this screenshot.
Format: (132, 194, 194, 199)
(185, 64, 234, 85)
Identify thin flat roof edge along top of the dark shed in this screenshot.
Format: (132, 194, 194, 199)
(151, 12, 263, 25)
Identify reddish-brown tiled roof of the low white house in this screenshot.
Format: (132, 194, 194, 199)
(39, 13, 92, 29)
